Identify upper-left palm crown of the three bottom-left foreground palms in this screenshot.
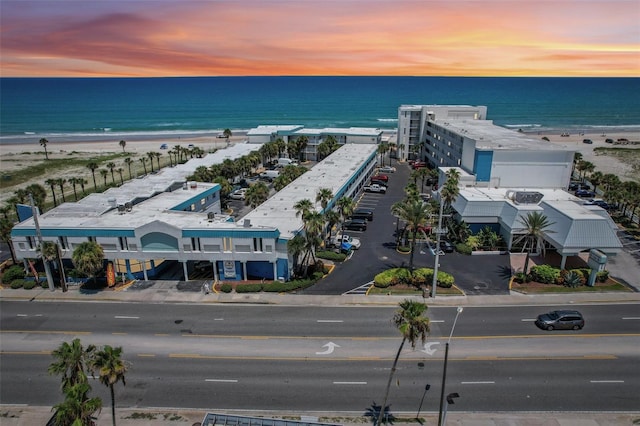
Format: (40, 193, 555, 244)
(47, 339, 96, 391)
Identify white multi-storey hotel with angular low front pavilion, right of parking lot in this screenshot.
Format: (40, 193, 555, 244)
(398, 105, 622, 268)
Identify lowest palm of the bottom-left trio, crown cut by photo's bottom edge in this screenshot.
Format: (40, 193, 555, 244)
(53, 382, 102, 426)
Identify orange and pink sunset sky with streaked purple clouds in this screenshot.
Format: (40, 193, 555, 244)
(0, 0, 640, 77)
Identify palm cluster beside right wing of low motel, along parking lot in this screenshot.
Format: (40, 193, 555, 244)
(287, 188, 355, 276)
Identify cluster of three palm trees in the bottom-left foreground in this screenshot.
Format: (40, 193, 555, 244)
(48, 339, 129, 426)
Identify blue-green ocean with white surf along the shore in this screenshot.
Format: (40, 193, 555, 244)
(0, 77, 640, 144)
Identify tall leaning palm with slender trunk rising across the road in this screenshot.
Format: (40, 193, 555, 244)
(374, 299, 430, 426)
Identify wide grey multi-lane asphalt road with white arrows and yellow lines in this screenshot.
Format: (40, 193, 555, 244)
(0, 301, 640, 413)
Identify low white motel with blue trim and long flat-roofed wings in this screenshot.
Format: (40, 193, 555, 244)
(12, 143, 377, 281)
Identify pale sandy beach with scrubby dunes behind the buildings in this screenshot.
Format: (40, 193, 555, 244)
(0, 130, 640, 203)
